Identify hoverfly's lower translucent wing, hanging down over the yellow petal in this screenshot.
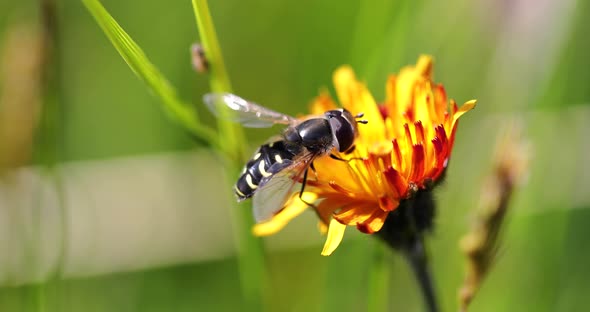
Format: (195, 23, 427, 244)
(252, 154, 316, 223)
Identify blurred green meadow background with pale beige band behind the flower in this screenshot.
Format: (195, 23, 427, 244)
(0, 0, 590, 311)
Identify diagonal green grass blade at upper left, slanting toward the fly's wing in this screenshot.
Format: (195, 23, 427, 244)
(82, 0, 217, 146)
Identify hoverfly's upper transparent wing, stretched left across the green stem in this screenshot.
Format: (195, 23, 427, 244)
(203, 93, 297, 128)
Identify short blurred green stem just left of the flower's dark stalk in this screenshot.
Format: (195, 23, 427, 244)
(367, 240, 391, 312)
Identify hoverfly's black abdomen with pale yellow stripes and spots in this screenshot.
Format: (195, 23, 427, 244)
(235, 141, 300, 201)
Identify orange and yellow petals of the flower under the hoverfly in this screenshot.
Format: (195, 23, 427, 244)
(254, 56, 475, 255)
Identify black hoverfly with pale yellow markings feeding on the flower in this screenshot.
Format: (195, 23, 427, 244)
(203, 93, 367, 222)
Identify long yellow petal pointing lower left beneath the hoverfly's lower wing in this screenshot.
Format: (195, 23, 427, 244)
(252, 192, 318, 236)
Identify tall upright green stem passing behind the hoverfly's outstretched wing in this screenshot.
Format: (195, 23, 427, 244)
(192, 0, 267, 311)
